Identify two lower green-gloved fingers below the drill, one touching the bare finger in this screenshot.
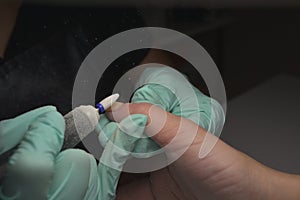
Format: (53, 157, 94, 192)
(48, 115, 147, 200)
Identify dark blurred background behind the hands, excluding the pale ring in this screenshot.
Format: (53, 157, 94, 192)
(0, 0, 300, 173)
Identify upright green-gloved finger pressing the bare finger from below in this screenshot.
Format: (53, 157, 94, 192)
(98, 114, 147, 200)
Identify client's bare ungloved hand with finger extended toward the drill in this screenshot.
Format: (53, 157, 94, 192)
(107, 103, 300, 200)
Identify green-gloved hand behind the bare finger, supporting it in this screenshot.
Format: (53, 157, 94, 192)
(123, 67, 225, 157)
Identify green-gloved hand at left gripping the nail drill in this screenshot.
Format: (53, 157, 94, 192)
(0, 106, 147, 200)
